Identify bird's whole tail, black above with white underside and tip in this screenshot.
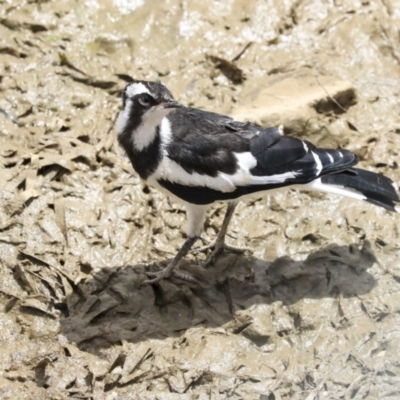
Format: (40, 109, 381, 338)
(305, 168, 400, 212)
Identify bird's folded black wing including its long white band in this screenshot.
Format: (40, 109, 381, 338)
(156, 109, 357, 193)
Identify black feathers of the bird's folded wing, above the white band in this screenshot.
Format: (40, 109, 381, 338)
(167, 108, 357, 184)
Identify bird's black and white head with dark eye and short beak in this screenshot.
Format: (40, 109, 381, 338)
(116, 80, 182, 135)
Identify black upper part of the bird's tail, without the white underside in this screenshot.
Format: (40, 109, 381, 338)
(321, 168, 400, 211)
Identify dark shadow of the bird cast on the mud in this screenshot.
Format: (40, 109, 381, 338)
(61, 242, 375, 353)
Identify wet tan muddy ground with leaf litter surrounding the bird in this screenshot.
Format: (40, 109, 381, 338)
(0, 0, 400, 400)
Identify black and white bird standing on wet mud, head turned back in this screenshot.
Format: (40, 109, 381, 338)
(116, 80, 400, 284)
